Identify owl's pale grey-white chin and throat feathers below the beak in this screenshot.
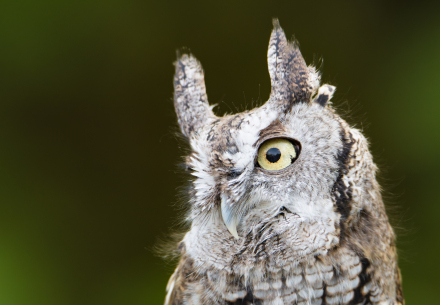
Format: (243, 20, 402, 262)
(183, 200, 339, 274)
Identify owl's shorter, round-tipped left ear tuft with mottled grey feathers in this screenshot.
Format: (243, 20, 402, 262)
(174, 53, 215, 137)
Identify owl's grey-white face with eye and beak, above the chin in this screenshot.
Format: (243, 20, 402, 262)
(189, 98, 343, 238)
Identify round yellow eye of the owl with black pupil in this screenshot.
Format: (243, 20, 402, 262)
(257, 139, 299, 171)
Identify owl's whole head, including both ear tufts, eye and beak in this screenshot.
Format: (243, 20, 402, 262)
(174, 20, 380, 257)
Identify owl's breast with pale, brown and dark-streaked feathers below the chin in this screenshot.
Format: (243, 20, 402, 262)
(168, 245, 382, 305)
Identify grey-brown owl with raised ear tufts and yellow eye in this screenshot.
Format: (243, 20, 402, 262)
(165, 20, 404, 305)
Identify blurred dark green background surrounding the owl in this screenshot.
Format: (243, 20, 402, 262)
(0, 0, 440, 305)
